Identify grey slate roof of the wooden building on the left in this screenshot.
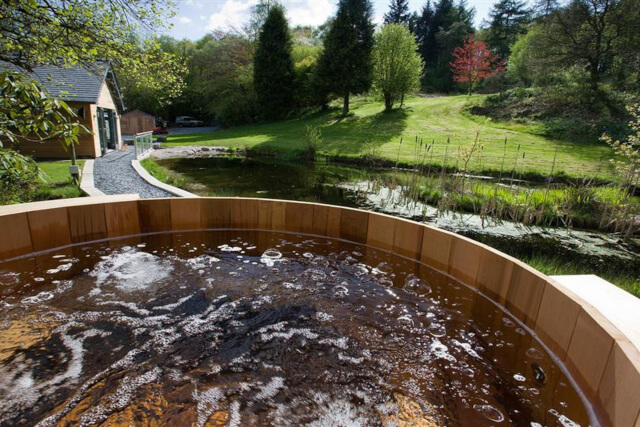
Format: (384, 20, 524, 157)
(0, 61, 119, 108)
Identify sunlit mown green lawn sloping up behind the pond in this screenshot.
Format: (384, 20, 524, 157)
(166, 95, 613, 179)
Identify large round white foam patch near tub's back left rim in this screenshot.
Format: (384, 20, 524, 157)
(89, 250, 173, 292)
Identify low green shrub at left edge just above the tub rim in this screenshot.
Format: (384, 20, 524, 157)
(0, 148, 44, 205)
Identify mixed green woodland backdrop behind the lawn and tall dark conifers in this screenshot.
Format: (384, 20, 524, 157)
(125, 0, 640, 145)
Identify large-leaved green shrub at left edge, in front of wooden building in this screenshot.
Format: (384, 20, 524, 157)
(0, 71, 89, 147)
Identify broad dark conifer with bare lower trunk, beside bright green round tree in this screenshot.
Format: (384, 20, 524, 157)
(316, 0, 374, 115)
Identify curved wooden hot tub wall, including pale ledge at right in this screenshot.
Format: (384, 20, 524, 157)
(0, 195, 640, 427)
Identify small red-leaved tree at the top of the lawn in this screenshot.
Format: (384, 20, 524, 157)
(451, 34, 504, 95)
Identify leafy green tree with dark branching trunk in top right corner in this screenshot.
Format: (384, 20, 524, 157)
(539, 0, 640, 91)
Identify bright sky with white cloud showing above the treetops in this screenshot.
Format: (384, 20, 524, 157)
(168, 0, 497, 40)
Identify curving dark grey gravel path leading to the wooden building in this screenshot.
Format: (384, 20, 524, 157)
(93, 151, 174, 199)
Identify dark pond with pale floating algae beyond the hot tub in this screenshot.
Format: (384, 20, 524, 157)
(158, 157, 640, 276)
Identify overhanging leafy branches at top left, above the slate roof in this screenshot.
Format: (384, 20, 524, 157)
(0, 0, 182, 107)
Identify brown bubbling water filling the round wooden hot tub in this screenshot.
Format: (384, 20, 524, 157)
(0, 231, 593, 427)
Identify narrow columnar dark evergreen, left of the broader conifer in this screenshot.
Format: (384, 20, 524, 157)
(253, 5, 295, 120)
